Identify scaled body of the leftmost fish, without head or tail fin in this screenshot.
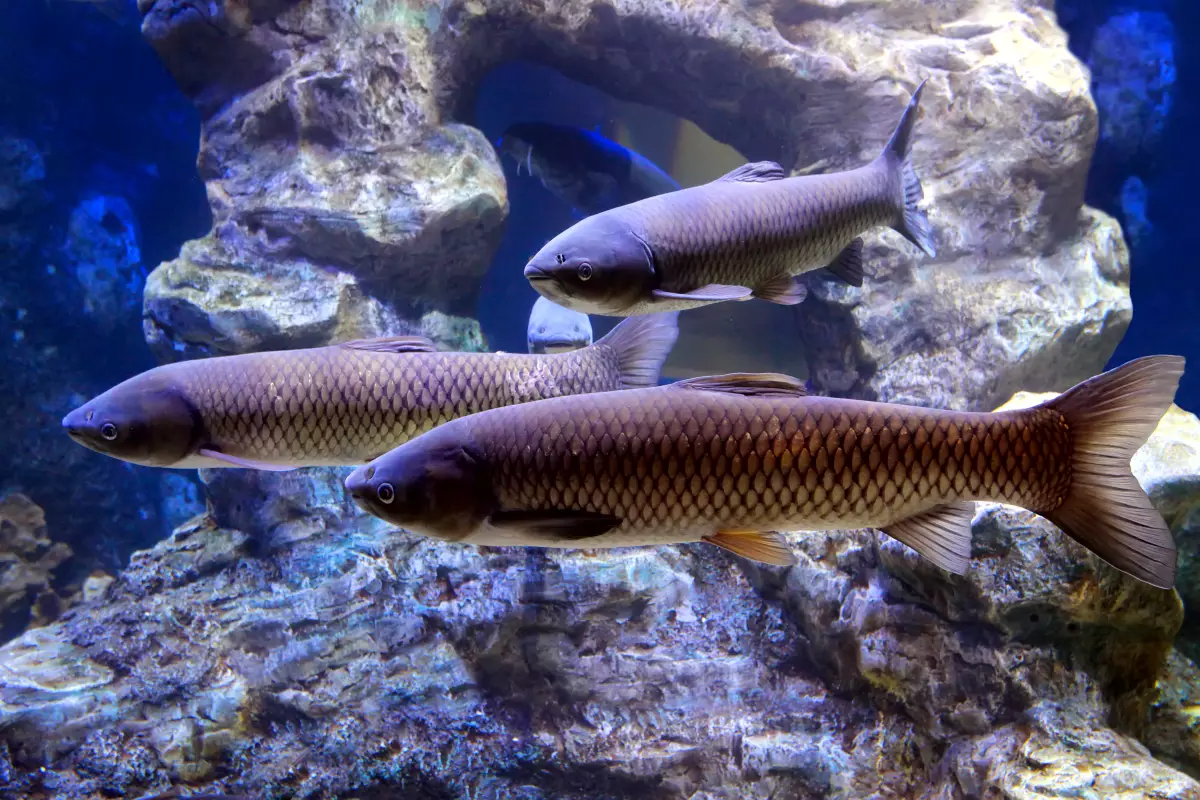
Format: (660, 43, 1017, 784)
(173, 345, 622, 467)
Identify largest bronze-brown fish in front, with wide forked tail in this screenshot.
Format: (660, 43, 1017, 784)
(346, 356, 1183, 588)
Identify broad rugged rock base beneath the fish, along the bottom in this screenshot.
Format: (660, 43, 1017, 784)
(0, 388, 1200, 800)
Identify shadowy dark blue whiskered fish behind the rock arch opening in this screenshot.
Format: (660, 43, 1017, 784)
(499, 122, 679, 213)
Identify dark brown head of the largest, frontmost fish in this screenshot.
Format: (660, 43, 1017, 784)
(346, 422, 496, 541)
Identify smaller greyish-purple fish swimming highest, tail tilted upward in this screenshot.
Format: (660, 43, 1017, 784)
(524, 82, 936, 317)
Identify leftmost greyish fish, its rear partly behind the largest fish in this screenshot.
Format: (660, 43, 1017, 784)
(62, 314, 679, 470)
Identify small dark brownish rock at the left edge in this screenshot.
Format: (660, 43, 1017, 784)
(0, 494, 71, 640)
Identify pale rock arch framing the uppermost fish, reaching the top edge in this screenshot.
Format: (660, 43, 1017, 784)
(136, 0, 1130, 409)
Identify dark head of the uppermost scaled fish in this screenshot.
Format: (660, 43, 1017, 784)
(524, 215, 654, 315)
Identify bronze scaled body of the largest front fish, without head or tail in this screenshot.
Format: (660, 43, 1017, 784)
(458, 390, 1070, 547)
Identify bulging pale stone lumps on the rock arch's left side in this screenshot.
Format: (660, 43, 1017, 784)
(144, 120, 505, 359)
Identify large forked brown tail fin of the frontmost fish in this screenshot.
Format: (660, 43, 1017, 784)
(1045, 355, 1184, 589)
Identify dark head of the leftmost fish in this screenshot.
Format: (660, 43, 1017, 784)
(62, 367, 203, 467)
